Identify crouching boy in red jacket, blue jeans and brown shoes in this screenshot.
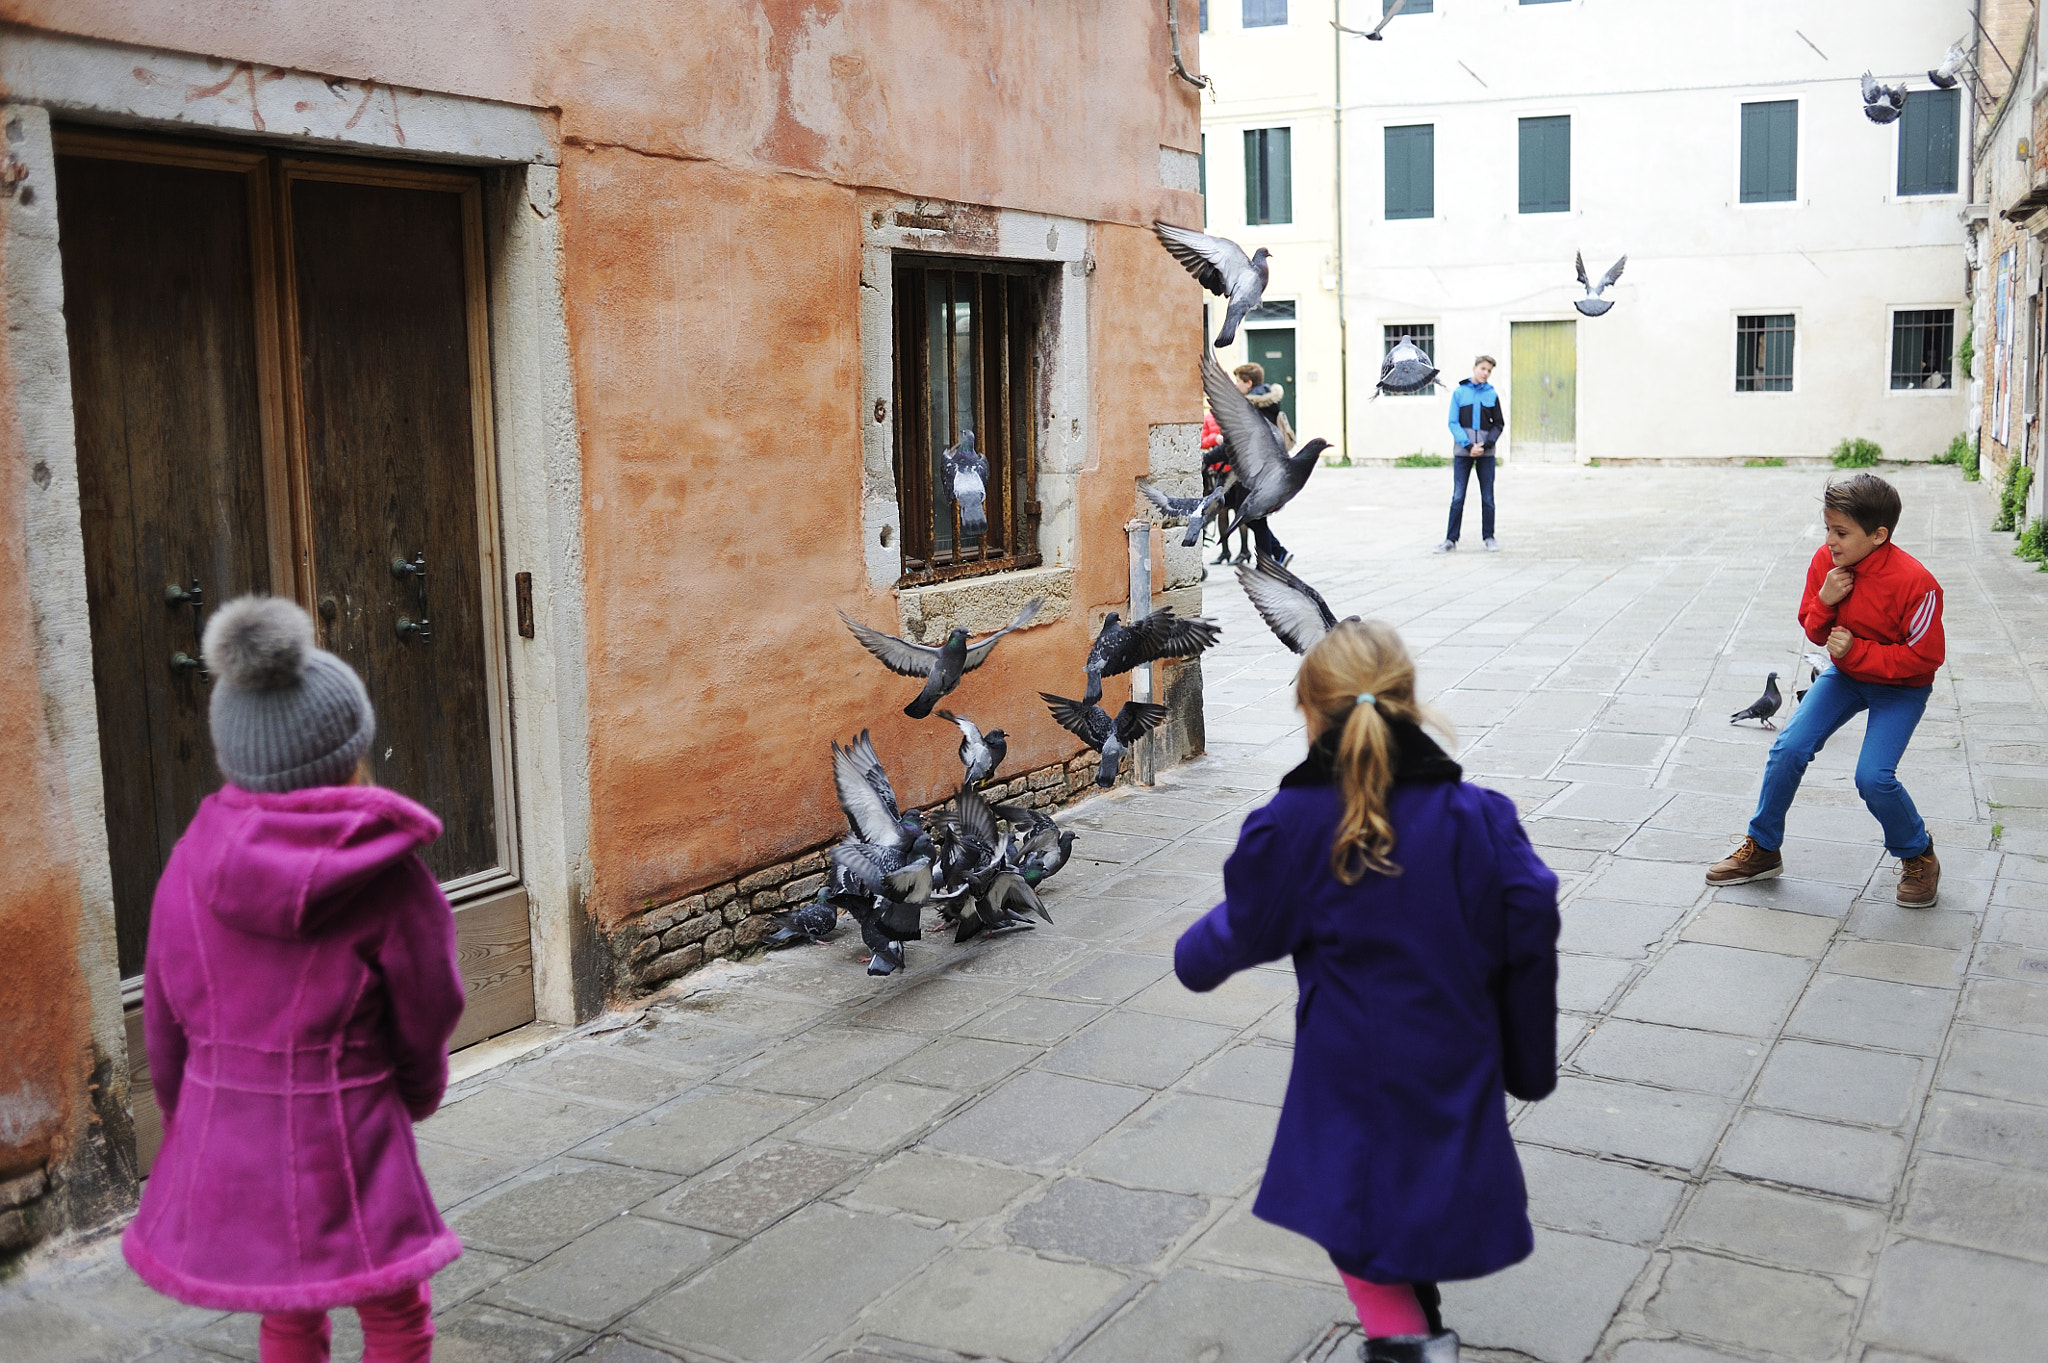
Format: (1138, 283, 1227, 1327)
(1706, 473, 1946, 909)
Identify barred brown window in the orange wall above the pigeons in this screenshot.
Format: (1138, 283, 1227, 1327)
(895, 256, 1047, 581)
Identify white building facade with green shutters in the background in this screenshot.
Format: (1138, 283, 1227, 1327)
(1200, 0, 1970, 463)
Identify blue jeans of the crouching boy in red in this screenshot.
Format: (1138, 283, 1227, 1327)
(1749, 667, 1933, 858)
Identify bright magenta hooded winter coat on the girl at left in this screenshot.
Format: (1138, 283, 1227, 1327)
(121, 786, 463, 1312)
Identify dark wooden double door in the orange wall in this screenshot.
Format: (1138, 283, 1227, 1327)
(57, 129, 532, 1121)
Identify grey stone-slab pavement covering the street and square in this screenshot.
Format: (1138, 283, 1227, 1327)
(12, 463, 2048, 1363)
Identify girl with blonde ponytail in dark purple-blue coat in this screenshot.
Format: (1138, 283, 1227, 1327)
(1174, 620, 1559, 1363)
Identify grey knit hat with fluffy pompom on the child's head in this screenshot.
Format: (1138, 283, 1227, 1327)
(201, 596, 377, 792)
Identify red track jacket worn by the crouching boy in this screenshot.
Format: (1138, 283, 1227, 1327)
(1798, 544, 1948, 686)
